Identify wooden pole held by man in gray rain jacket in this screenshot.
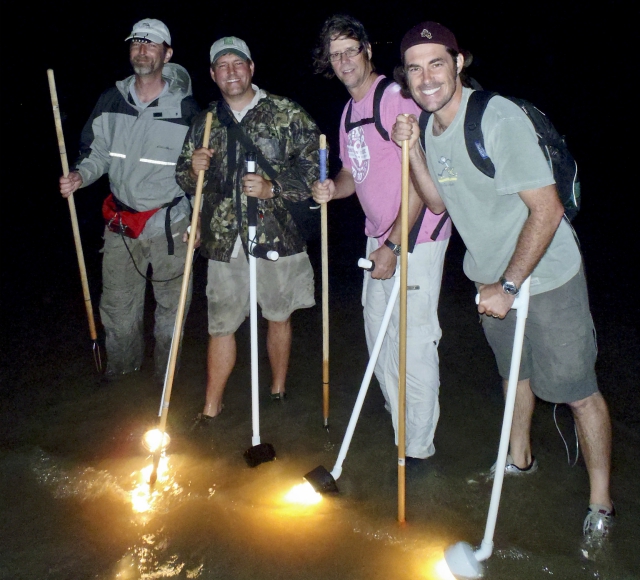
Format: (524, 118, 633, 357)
(47, 69, 102, 372)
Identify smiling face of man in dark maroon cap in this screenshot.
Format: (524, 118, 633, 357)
(404, 43, 464, 119)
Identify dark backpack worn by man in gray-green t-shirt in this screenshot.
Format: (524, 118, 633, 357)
(419, 91, 580, 221)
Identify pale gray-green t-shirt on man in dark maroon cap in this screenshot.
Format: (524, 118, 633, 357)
(425, 88, 581, 294)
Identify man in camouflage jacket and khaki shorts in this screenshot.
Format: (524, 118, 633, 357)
(176, 36, 320, 426)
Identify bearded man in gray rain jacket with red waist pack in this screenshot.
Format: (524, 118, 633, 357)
(60, 18, 199, 380)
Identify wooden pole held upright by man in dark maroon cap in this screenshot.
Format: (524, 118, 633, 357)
(398, 141, 409, 523)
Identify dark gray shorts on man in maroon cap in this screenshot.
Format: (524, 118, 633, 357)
(480, 268, 598, 403)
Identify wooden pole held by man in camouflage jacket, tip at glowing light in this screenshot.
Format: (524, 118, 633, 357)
(149, 112, 213, 484)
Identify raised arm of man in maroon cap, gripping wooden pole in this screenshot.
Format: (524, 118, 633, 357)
(391, 115, 446, 215)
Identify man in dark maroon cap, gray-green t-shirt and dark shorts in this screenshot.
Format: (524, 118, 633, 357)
(392, 22, 615, 546)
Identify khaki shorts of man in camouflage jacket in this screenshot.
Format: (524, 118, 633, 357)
(207, 251, 315, 337)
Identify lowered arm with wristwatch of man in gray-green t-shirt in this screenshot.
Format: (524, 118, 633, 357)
(478, 185, 564, 318)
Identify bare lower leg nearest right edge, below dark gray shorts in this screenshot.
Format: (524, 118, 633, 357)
(569, 392, 612, 509)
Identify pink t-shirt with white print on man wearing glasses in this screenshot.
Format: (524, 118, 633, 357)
(340, 75, 451, 244)
